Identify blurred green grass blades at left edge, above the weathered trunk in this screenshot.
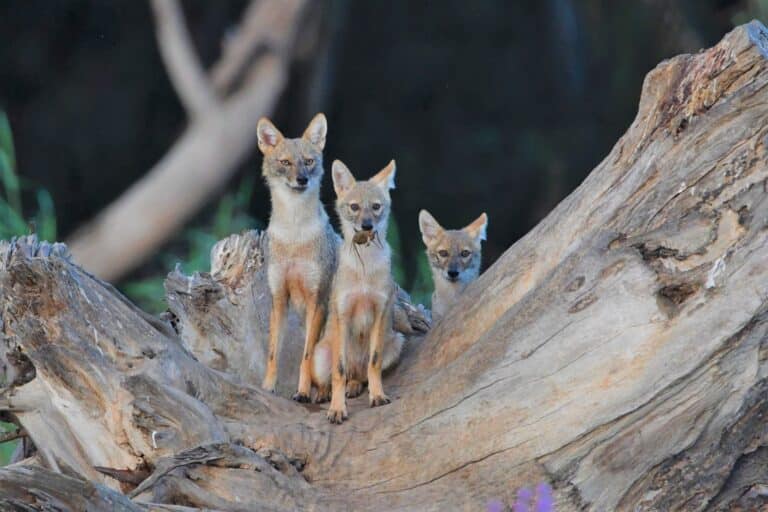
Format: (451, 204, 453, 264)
(0, 112, 56, 241)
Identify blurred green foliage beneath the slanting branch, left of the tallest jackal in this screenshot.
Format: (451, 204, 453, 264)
(121, 177, 260, 313)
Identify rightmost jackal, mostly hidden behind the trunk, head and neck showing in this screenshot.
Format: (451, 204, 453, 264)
(419, 210, 488, 319)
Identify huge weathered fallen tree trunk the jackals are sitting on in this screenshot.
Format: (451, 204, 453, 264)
(0, 22, 768, 511)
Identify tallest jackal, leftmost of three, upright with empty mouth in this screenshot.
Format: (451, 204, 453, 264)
(257, 114, 340, 402)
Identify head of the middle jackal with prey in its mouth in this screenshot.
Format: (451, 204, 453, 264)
(331, 160, 395, 241)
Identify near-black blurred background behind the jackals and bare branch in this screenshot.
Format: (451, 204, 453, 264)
(0, 0, 764, 298)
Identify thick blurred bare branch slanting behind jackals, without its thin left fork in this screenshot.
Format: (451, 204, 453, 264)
(69, 0, 307, 279)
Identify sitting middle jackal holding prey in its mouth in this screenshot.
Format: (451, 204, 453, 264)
(313, 160, 403, 423)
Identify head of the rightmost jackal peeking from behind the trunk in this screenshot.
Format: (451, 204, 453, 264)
(419, 210, 488, 284)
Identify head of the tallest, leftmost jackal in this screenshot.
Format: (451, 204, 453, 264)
(256, 113, 328, 194)
